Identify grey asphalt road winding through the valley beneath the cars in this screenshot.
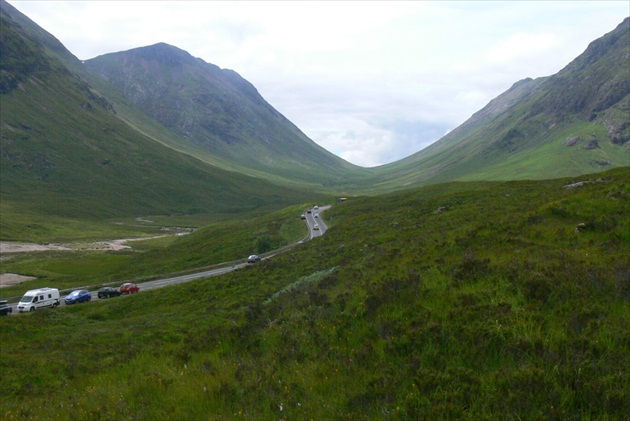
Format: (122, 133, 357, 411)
(3, 206, 330, 315)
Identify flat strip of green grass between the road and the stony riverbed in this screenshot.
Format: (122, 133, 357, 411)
(0, 204, 314, 297)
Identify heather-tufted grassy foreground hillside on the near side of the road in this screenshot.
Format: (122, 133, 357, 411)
(0, 168, 630, 420)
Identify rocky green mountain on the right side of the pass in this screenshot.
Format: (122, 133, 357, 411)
(374, 19, 630, 189)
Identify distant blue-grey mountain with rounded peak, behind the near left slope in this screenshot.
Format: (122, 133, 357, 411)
(85, 43, 365, 185)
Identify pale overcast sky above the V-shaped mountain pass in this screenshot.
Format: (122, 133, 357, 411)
(9, 0, 630, 167)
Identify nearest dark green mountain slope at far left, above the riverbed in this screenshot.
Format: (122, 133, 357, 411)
(0, 1, 314, 226)
